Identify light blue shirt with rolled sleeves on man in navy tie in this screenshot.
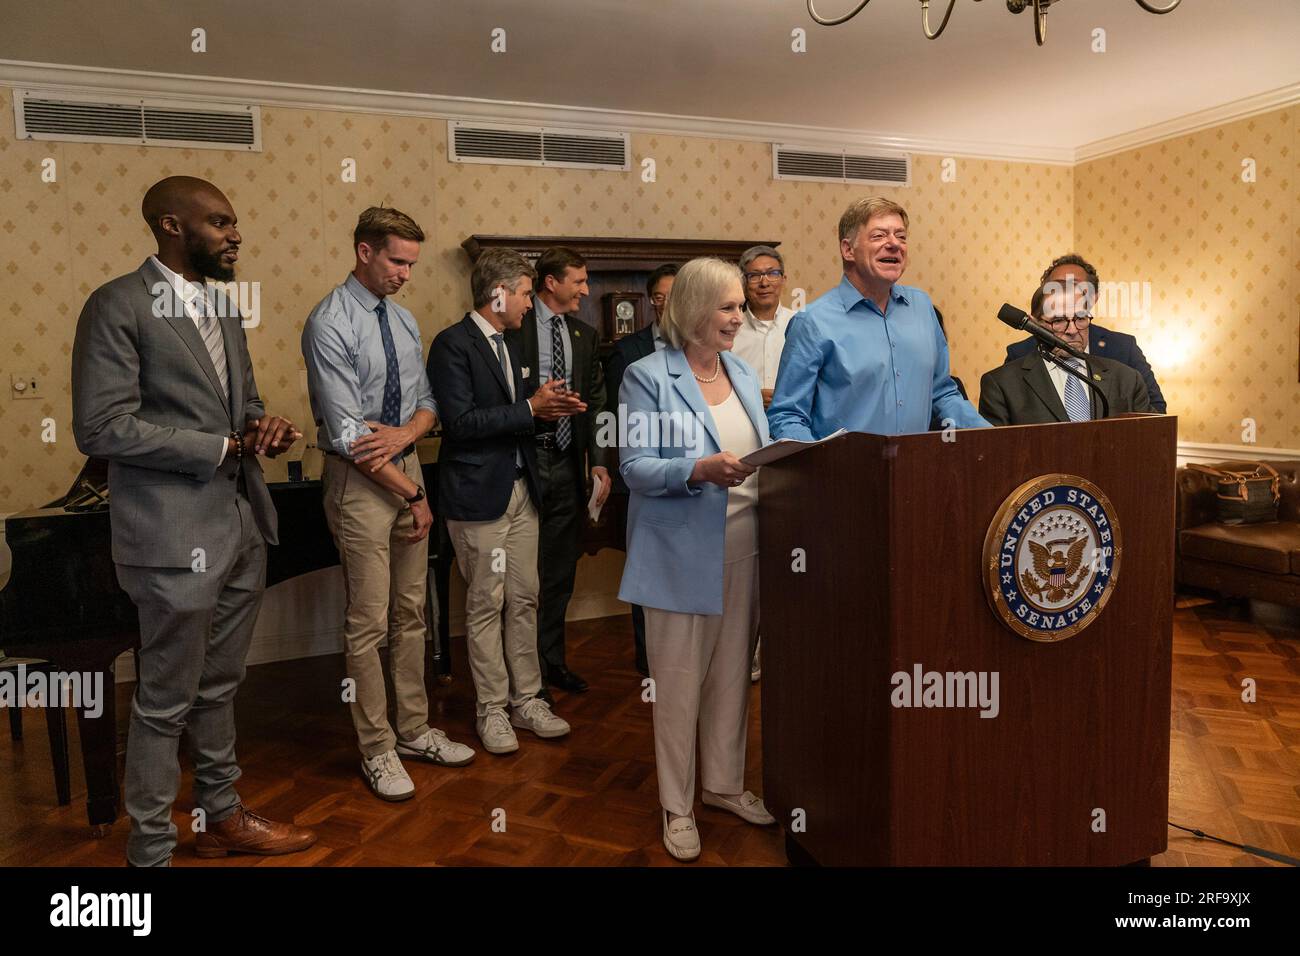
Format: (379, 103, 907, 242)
(303, 274, 438, 458)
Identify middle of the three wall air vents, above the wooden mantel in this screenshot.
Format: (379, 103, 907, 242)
(447, 120, 632, 172)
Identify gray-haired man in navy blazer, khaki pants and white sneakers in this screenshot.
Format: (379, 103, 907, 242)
(428, 250, 586, 753)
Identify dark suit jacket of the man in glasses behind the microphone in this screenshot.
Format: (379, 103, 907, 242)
(979, 351, 1153, 425)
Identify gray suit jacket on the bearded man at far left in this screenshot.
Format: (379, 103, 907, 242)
(73, 259, 277, 567)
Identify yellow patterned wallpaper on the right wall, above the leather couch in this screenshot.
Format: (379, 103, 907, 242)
(1074, 108, 1300, 449)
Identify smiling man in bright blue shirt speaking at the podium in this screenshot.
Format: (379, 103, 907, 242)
(767, 198, 988, 441)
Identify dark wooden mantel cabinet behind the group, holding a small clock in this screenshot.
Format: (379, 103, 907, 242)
(460, 235, 780, 554)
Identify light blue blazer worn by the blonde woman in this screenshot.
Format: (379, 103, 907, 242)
(619, 349, 771, 614)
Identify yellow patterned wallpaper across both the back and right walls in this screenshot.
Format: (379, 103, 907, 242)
(0, 88, 1300, 514)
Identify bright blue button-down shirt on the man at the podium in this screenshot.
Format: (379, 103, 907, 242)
(767, 276, 988, 441)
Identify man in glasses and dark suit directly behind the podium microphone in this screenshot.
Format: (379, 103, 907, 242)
(979, 282, 1152, 425)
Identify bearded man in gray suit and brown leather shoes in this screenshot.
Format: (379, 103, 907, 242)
(73, 176, 316, 866)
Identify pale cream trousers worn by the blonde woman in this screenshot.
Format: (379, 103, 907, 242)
(645, 554, 758, 816)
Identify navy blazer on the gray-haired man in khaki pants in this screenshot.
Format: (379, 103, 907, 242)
(428, 313, 541, 522)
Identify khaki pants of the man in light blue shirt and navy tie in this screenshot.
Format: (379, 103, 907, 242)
(321, 454, 429, 757)
